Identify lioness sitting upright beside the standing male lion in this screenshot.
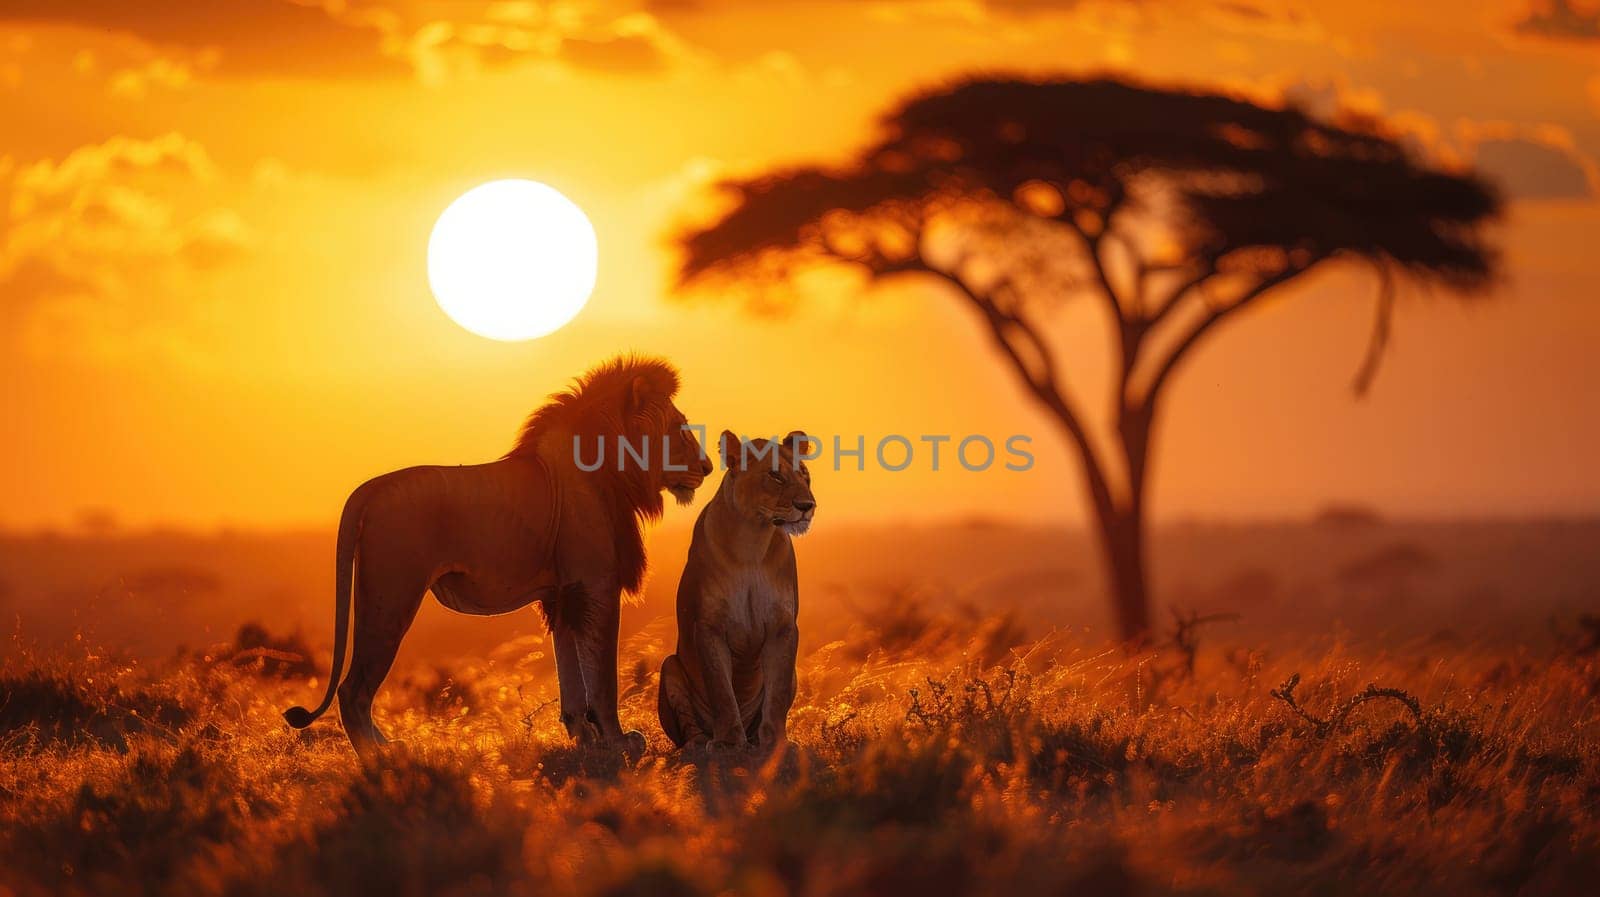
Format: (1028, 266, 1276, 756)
(656, 430, 816, 751)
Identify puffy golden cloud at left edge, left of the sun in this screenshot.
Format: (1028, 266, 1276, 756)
(0, 134, 253, 357)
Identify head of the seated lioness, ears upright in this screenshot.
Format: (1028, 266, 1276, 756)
(718, 430, 816, 536)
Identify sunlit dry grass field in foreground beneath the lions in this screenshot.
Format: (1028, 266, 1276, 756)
(0, 604, 1600, 895)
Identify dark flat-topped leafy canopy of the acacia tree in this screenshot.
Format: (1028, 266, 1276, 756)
(683, 78, 1499, 289)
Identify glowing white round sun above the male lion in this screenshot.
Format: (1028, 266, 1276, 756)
(427, 179, 598, 341)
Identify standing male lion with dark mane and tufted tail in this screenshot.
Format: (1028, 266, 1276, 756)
(283, 357, 712, 759)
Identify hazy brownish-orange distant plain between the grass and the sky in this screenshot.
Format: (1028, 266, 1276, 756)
(0, 508, 1600, 675)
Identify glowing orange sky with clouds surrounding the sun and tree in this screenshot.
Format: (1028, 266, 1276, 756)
(0, 0, 1600, 528)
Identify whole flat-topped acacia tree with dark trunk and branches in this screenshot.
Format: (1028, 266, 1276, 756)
(680, 78, 1499, 640)
